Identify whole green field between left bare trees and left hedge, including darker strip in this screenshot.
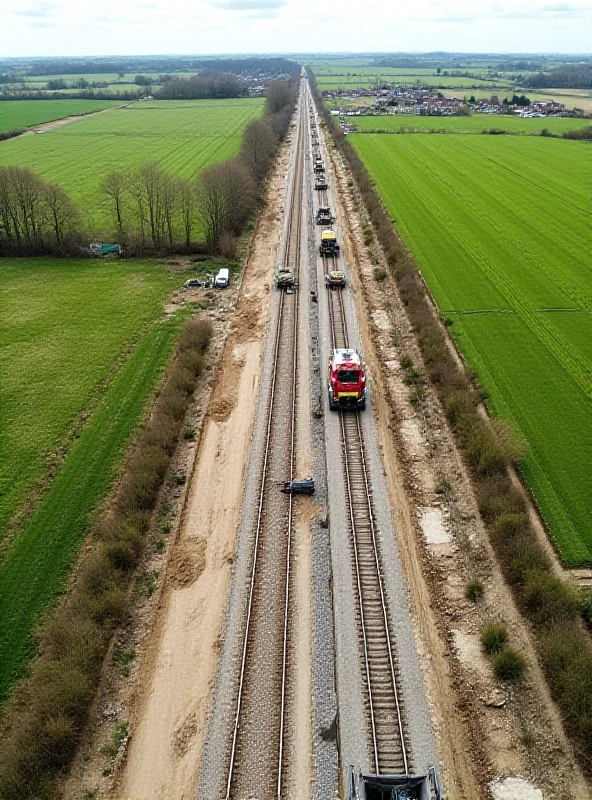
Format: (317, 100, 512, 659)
(0, 259, 190, 698)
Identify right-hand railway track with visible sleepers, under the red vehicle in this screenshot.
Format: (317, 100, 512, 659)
(323, 188, 411, 775)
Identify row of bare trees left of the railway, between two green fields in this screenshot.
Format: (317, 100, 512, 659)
(0, 81, 296, 256)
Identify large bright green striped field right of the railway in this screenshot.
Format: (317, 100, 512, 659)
(351, 134, 592, 565)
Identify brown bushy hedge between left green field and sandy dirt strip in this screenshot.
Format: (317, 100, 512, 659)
(0, 319, 212, 800)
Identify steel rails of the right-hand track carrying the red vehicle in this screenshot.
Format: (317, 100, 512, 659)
(328, 282, 409, 775)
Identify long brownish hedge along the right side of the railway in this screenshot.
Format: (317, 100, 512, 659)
(306, 67, 592, 777)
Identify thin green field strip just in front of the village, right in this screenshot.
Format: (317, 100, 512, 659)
(352, 114, 592, 134)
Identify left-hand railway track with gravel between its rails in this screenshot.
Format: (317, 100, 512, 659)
(226, 89, 304, 800)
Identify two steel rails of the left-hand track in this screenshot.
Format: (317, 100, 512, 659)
(226, 95, 303, 800)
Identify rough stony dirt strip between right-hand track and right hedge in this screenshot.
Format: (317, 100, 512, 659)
(332, 141, 592, 800)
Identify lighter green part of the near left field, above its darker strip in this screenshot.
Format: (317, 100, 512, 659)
(0, 259, 180, 540)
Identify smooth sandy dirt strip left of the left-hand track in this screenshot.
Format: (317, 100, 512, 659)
(65, 142, 289, 800)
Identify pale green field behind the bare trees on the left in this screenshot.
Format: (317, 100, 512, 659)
(0, 99, 263, 229)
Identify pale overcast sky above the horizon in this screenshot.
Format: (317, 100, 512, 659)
(0, 0, 592, 57)
